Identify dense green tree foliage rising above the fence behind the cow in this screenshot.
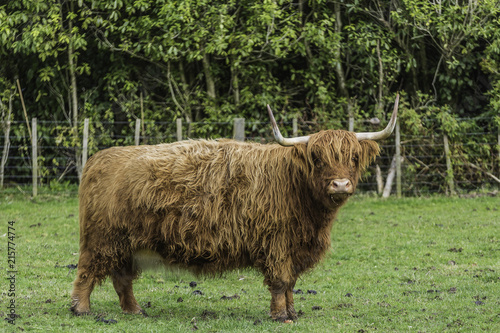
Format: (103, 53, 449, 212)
(0, 0, 500, 189)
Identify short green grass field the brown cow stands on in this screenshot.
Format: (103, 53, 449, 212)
(0, 194, 500, 332)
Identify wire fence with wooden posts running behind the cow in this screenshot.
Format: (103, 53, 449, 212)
(0, 119, 500, 196)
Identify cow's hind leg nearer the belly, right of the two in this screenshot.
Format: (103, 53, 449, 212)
(111, 260, 146, 315)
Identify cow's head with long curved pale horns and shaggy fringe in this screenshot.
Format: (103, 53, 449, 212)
(268, 95, 399, 209)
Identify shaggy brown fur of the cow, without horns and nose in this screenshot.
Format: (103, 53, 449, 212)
(72, 131, 379, 321)
